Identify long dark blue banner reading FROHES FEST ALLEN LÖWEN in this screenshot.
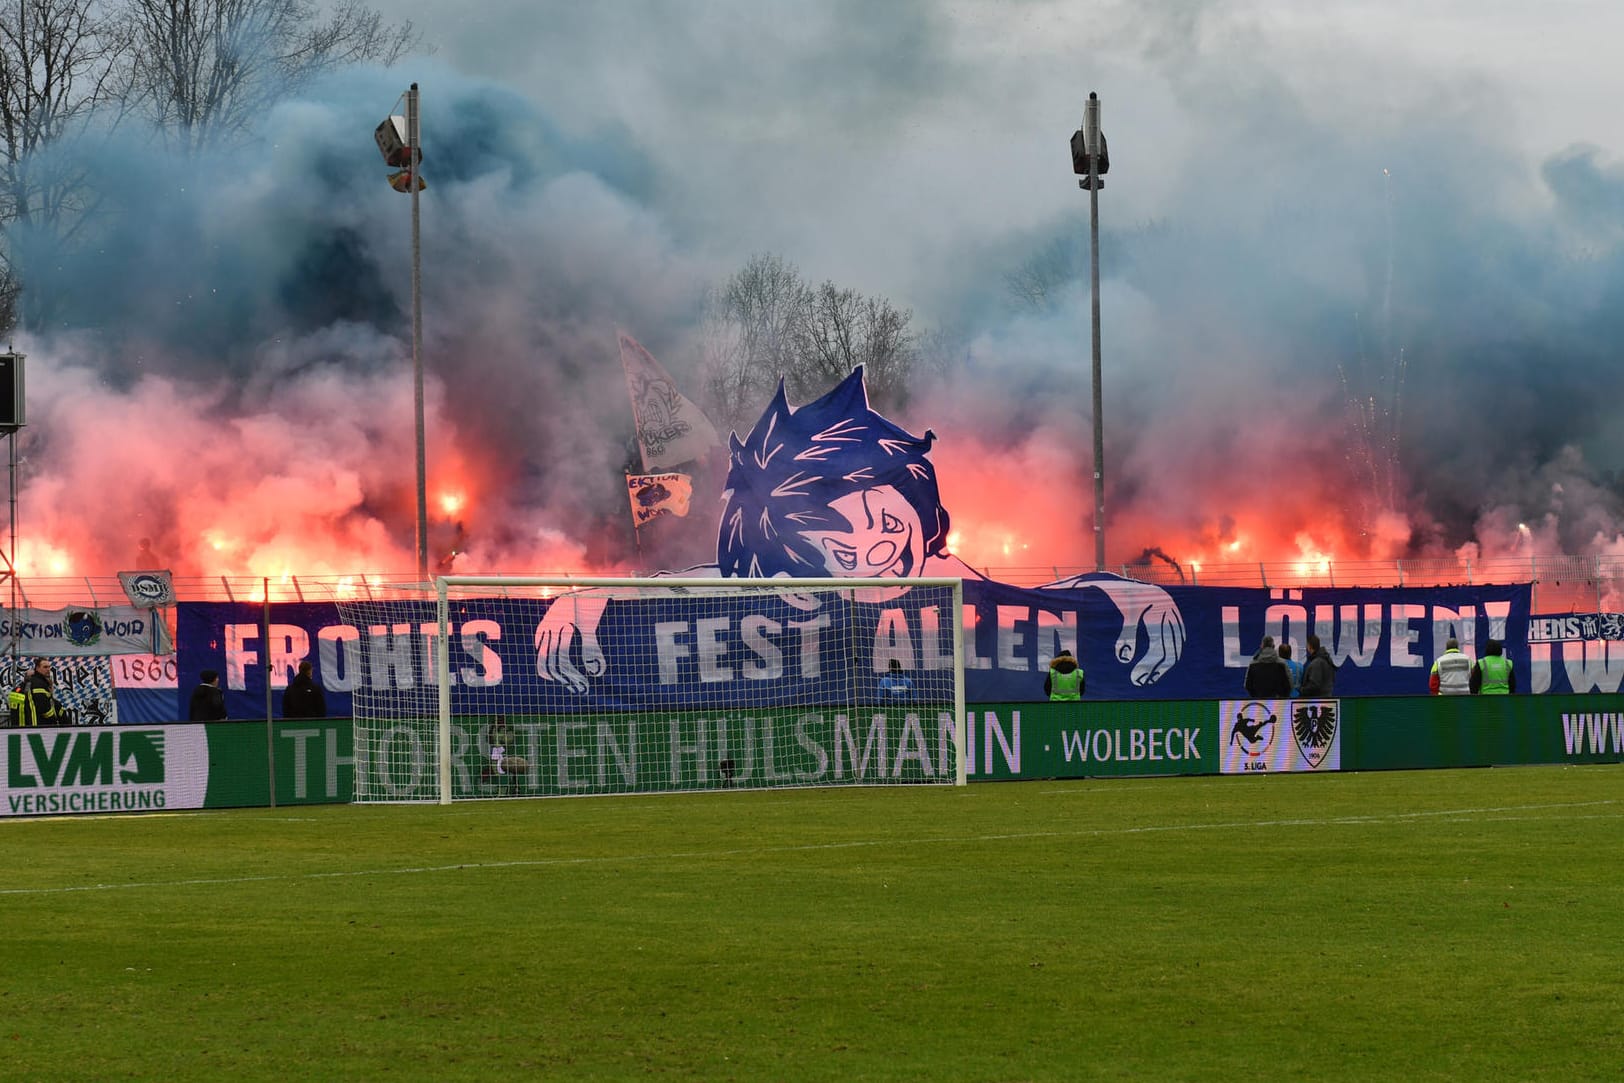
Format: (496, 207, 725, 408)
(177, 576, 1530, 718)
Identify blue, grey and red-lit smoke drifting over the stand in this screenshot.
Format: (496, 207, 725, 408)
(16, 5, 1624, 576)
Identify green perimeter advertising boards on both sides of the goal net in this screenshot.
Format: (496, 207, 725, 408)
(0, 695, 1624, 817)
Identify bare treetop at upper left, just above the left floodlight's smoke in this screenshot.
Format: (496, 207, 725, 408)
(114, 0, 419, 151)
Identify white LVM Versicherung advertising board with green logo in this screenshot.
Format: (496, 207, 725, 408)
(5, 729, 166, 813)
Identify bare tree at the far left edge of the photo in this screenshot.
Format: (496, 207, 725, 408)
(0, 0, 120, 326)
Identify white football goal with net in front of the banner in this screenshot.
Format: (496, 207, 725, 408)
(339, 576, 966, 802)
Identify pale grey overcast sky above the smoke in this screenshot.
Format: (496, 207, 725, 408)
(380, 0, 1624, 305)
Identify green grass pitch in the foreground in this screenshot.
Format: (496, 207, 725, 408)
(0, 766, 1624, 1081)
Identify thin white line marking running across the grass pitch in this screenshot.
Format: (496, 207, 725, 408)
(0, 799, 1618, 896)
